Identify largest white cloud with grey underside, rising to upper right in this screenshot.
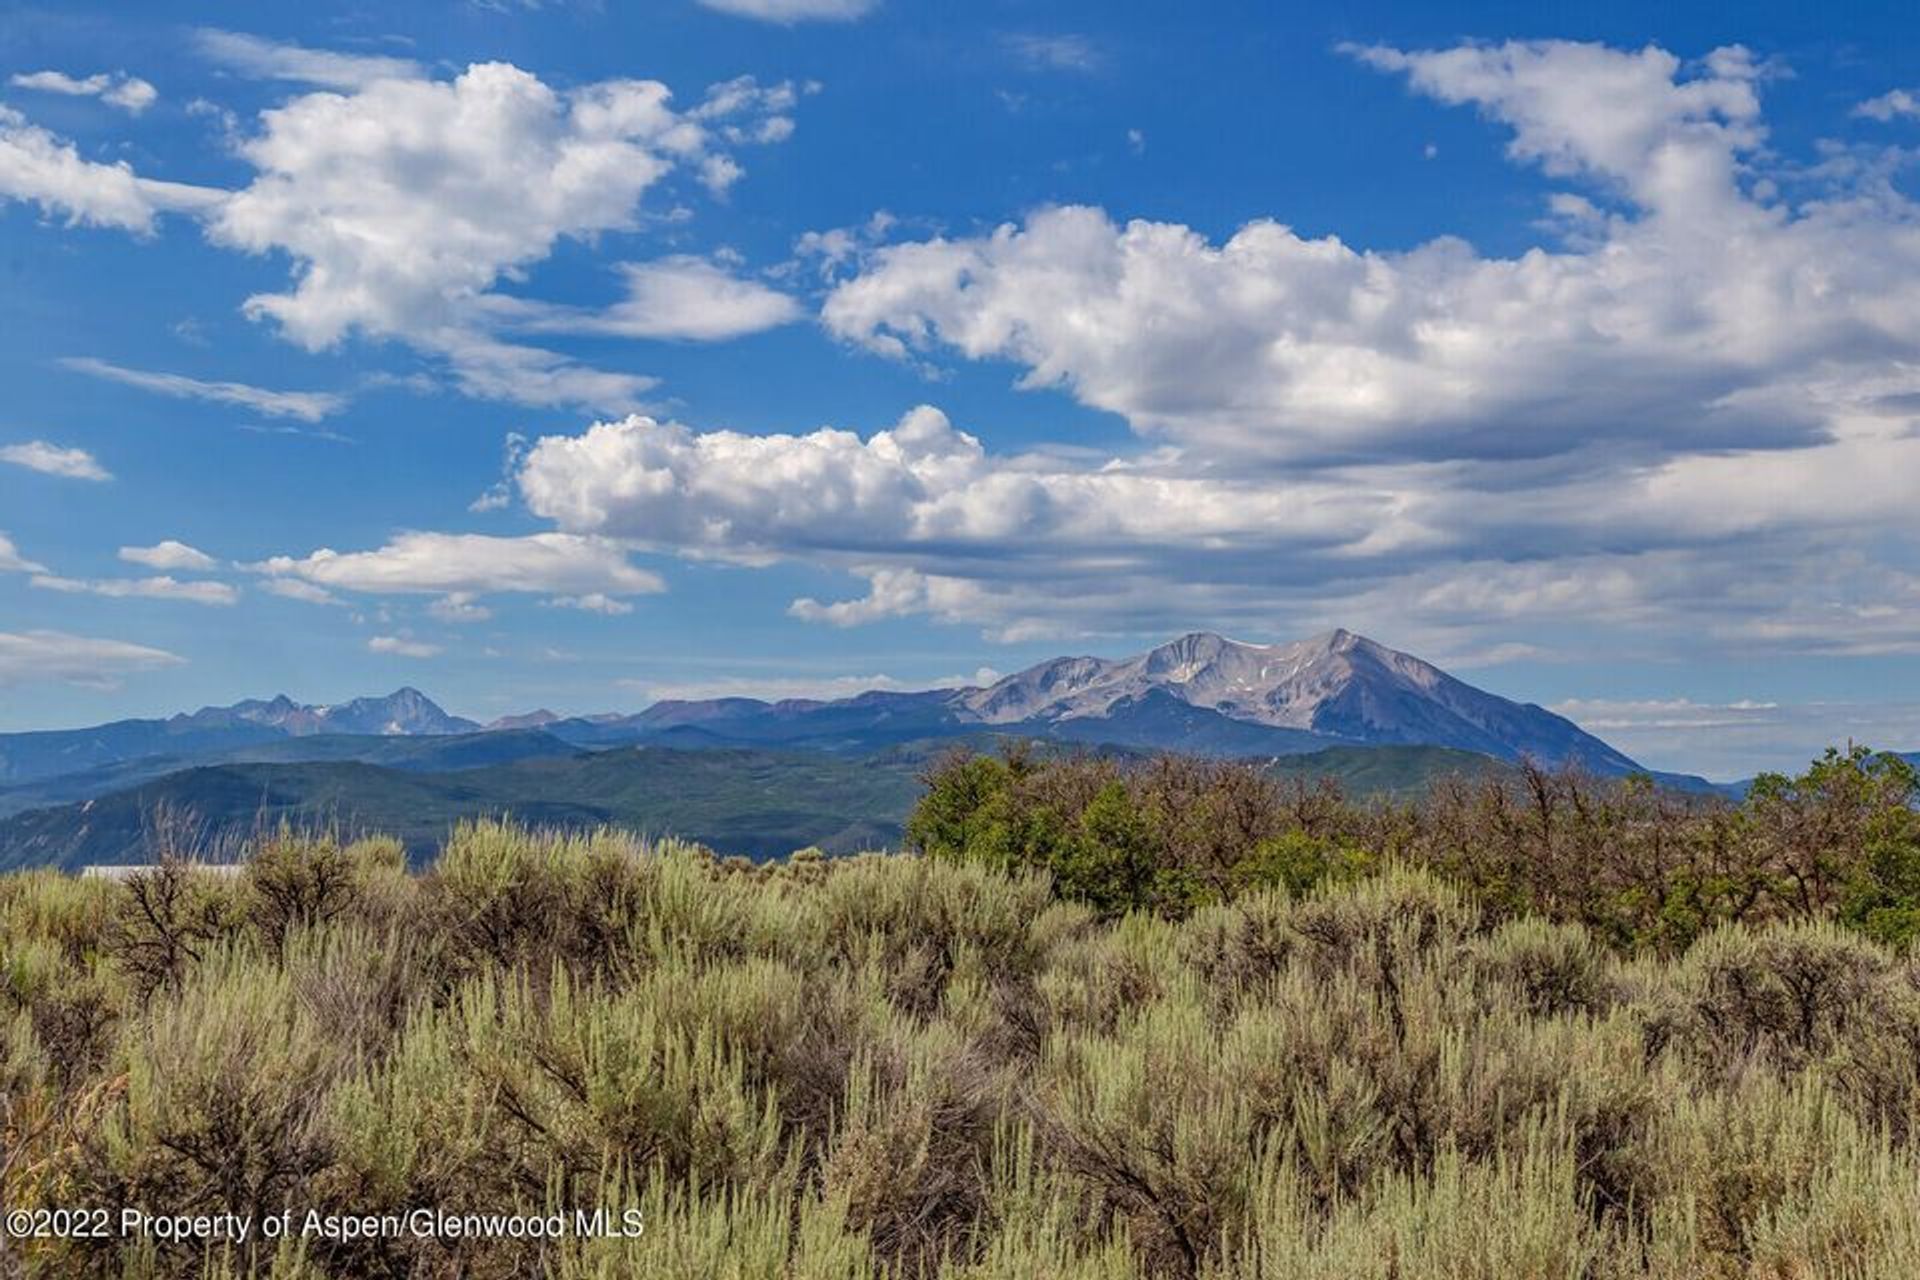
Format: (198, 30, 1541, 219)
(824, 44, 1920, 475)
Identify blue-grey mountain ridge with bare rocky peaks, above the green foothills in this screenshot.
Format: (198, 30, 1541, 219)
(0, 631, 1640, 785)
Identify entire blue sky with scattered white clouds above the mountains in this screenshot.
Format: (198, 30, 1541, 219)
(0, 0, 1920, 775)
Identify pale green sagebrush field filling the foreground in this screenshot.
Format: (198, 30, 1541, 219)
(0, 758, 1920, 1280)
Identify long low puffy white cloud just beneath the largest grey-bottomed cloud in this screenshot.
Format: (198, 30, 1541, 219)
(518, 405, 1417, 560)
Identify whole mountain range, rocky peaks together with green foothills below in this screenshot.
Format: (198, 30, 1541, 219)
(0, 631, 1709, 864)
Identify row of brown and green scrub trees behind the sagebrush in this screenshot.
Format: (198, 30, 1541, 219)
(906, 747, 1920, 954)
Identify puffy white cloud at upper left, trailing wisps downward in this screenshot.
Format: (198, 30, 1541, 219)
(209, 63, 793, 409)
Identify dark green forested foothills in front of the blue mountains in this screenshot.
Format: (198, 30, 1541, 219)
(0, 731, 1501, 869)
